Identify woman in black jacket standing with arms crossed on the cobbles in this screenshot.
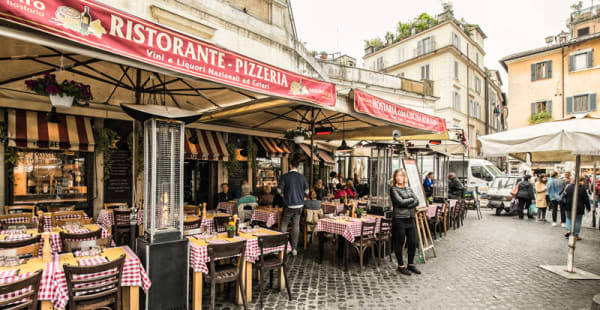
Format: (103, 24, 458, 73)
(390, 169, 421, 276)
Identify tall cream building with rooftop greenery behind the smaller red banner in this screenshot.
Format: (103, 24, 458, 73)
(363, 8, 504, 156)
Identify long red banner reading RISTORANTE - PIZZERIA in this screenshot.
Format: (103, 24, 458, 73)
(0, 0, 335, 107)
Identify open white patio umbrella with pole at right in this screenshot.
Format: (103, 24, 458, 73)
(479, 114, 600, 273)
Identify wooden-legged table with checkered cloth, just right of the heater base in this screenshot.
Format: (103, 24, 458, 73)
(188, 228, 292, 310)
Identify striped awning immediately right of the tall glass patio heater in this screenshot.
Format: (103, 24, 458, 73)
(184, 129, 229, 161)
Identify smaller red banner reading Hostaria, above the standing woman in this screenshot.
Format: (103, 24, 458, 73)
(354, 89, 446, 132)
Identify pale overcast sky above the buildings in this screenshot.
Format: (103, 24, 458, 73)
(291, 0, 576, 90)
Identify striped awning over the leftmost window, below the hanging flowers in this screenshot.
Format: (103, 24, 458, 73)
(8, 109, 95, 152)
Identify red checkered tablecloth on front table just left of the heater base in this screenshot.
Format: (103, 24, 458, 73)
(51, 246, 151, 309)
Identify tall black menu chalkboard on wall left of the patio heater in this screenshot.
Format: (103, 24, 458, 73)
(104, 120, 132, 205)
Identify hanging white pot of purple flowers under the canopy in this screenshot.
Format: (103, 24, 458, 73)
(25, 73, 93, 108)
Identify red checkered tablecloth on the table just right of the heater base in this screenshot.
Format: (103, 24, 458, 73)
(190, 237, 292, 273)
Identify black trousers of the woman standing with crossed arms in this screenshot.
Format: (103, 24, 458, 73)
(392, 218, 417, 266)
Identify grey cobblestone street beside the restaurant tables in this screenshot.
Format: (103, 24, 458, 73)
(210, 210, 600, 309)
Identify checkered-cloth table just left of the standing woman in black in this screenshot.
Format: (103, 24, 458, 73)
(315, 214, 383, 271)
